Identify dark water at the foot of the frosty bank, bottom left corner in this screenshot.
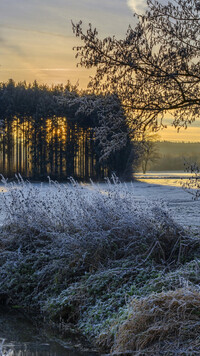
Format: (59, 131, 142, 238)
(0, 306, 98, 356)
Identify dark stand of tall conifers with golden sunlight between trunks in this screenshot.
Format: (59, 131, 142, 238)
(0, 80, 137, 180)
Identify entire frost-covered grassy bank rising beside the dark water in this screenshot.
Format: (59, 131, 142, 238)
(0, 179, 200, 355)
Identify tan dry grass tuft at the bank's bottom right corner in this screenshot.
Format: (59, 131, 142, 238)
(111, 289, 200, 355)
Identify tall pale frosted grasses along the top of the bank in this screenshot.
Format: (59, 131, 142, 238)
(0, 177, 183, 267)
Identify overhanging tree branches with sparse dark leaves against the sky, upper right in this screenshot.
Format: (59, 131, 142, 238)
(73, 0, 200, 129)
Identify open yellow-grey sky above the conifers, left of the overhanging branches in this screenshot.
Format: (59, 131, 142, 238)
(0, 0, 145, 87)
